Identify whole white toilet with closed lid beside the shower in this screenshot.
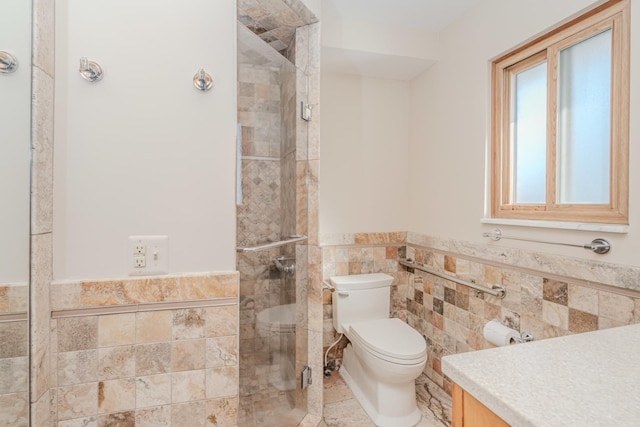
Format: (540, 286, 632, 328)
(331, 273, 427, 427)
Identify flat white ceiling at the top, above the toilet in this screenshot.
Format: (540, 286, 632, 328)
(322, 0, 480, 32)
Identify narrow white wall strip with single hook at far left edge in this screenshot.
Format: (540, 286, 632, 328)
(0, 0, 31, 285)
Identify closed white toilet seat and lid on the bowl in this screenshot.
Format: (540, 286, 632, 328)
(348, 318, 427, 365)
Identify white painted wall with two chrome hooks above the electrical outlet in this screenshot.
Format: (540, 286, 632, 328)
(54, 0, 236, 280)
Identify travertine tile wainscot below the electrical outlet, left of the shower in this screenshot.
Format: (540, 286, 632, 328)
(51, 273, 238, 427)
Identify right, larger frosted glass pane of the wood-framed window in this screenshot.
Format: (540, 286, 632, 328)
(558, 30, 611, 204)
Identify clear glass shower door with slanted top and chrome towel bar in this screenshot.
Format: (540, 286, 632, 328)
(236, 15, 310, 426)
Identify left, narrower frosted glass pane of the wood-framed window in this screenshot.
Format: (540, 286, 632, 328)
(512, 62, 547, 204)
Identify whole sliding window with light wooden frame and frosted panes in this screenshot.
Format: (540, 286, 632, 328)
(491, 0, 630, 224)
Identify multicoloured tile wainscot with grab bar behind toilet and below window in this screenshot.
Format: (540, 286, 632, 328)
(323, 234, 640, 393)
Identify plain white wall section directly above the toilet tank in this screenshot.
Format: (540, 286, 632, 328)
(319, 72, 409, 233)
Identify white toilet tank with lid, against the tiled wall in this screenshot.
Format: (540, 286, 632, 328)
(331, 273, 393, 333)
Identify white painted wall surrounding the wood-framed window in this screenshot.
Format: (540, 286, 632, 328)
(408, 0, 640, 266)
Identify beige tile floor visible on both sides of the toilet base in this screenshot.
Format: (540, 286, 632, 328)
(319, 372, 451, 427)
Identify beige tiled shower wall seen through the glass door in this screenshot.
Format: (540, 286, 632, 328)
(238, 20, 322, 425)
